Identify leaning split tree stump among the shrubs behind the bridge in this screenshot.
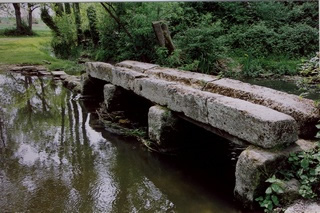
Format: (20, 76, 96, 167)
(152, 21, 175, 54)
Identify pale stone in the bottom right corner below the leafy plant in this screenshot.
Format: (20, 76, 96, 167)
(284, 200, 320, 213)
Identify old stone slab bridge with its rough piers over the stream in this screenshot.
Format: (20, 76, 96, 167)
(84, 61, 320, 206)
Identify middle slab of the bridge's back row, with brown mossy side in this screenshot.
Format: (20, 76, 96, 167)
(145, 67, 218, 89)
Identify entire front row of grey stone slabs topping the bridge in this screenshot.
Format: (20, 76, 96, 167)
(86, 62, 298, 148)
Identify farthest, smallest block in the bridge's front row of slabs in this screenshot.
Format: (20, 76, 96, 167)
(85, 62, 114, 82)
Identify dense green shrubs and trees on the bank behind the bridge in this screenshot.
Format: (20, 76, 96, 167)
(42, 1, 319, 77)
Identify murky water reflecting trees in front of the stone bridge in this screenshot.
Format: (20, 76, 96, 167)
(0, 73, 242, 212)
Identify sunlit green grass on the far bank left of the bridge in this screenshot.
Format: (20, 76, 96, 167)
(0, 29, 83, 74)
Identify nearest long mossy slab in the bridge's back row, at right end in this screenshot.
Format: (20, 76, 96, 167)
(204, 78, 320, 137)
